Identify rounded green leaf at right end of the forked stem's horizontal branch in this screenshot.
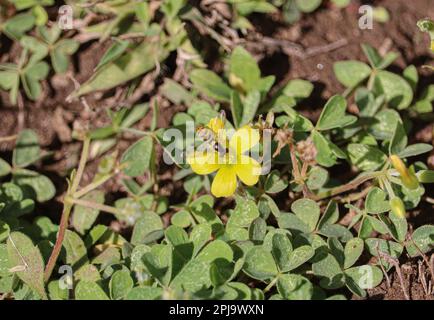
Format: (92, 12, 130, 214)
(131, 211, 163, 245)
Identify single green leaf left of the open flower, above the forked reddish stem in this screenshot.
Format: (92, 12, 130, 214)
(121, 136, 154, 177)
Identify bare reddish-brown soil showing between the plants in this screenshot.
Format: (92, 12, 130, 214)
(0, 0, 434, 299)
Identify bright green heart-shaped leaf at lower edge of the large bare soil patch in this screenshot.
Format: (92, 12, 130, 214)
(316, 95, 357, 130)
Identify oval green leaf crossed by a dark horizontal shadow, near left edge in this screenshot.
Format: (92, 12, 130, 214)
(12, 129, 41, 167)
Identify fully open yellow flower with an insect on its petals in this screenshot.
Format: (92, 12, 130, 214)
(187, 118, 261, 197)
